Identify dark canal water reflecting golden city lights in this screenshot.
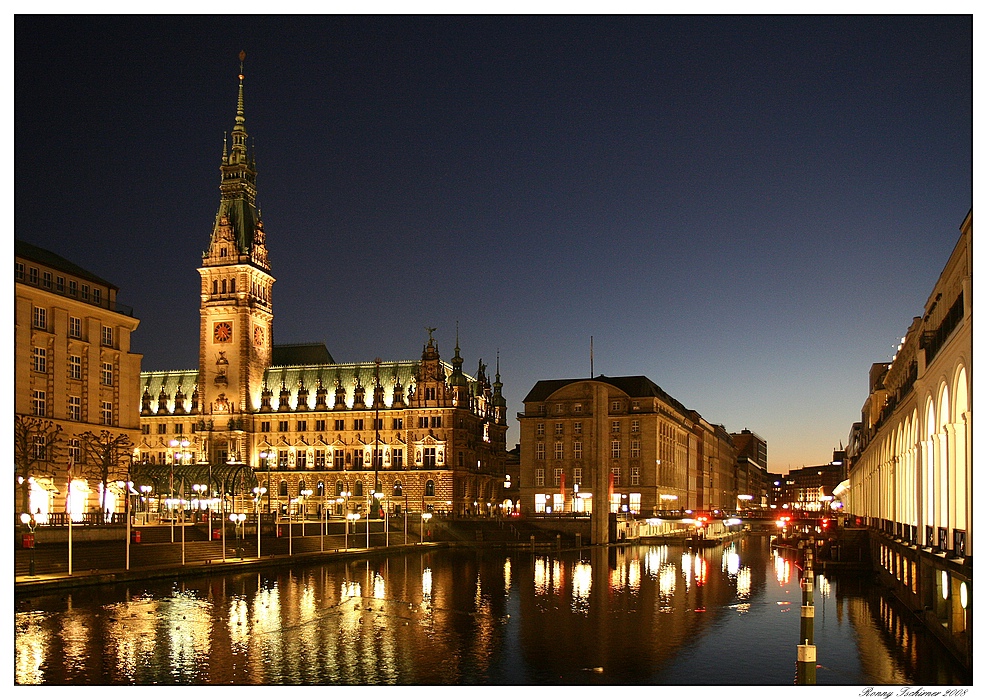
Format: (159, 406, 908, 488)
(14, 536, 970, 686)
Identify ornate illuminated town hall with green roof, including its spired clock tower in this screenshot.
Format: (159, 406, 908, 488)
(138, 61, 507, 515)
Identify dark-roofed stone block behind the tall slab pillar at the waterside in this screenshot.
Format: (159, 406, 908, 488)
(518, 375, 737, 516)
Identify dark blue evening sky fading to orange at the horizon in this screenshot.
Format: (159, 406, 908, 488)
(14, 16, 973, 471)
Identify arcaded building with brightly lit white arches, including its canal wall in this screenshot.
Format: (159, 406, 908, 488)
(842, 206, 974, 665)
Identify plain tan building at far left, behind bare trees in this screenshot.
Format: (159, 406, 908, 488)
(14, 241, 141, 521)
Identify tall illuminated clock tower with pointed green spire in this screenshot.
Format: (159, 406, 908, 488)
(198, 52, 274, 432)
